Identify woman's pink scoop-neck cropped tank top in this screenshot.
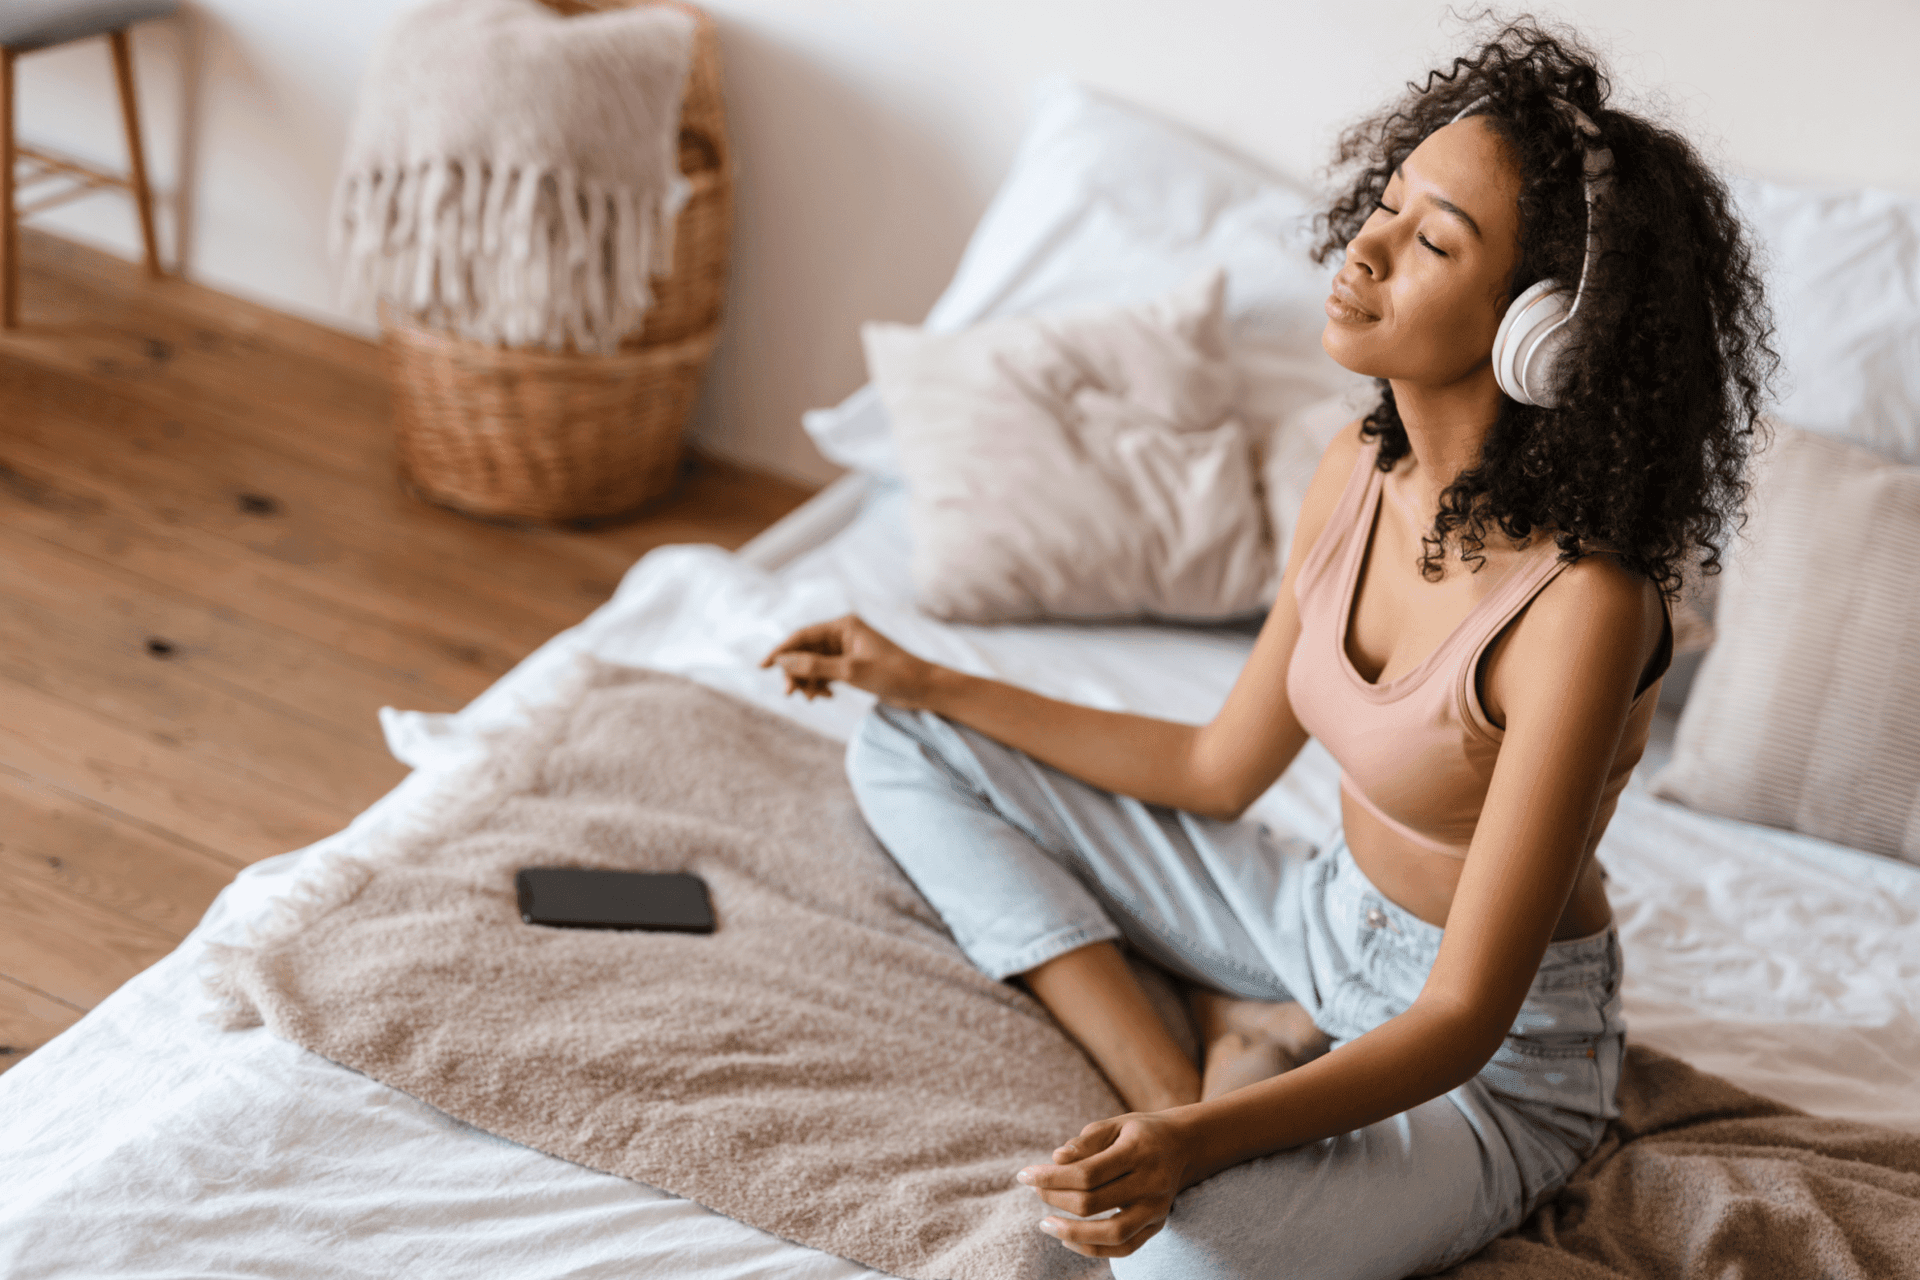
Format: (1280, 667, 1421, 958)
(1286, 438, 1672, 858)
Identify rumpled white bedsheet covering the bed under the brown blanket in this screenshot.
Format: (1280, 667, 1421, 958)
(0, 482, 1920, 1280)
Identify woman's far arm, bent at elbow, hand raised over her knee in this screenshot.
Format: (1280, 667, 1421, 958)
(760, 422, 1361, 819)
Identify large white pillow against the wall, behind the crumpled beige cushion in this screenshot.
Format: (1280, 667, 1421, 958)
(801, 81, 1356, 485)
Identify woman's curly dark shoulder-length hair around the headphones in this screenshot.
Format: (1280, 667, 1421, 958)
(1313, 17, 1780, 599)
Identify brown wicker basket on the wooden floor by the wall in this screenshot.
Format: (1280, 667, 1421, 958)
(382, 0, 733, 524)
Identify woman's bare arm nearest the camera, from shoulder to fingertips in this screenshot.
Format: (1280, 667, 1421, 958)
(1021, 557, 1661, 1253)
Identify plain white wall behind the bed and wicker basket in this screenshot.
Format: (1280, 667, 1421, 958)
(19, 0, 1920, 480)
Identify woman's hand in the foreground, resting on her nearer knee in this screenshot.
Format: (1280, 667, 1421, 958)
(1020, 1111, 1190, 1257)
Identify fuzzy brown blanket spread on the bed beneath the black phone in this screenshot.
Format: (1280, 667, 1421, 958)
(215, 666, 1920, 1280)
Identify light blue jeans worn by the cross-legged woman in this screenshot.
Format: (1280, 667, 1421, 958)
(847, 704, 1624, 1280)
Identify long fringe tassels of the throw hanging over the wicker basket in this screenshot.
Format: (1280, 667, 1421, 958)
(328, 157, 691, 353)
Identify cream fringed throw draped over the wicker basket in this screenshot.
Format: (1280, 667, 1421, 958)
(332, 0, 693, 351)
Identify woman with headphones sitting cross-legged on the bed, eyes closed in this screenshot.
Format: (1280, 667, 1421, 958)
(766, 21, 1772, 1276)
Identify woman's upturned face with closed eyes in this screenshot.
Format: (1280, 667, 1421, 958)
(1321, 115, 1521, 388)
